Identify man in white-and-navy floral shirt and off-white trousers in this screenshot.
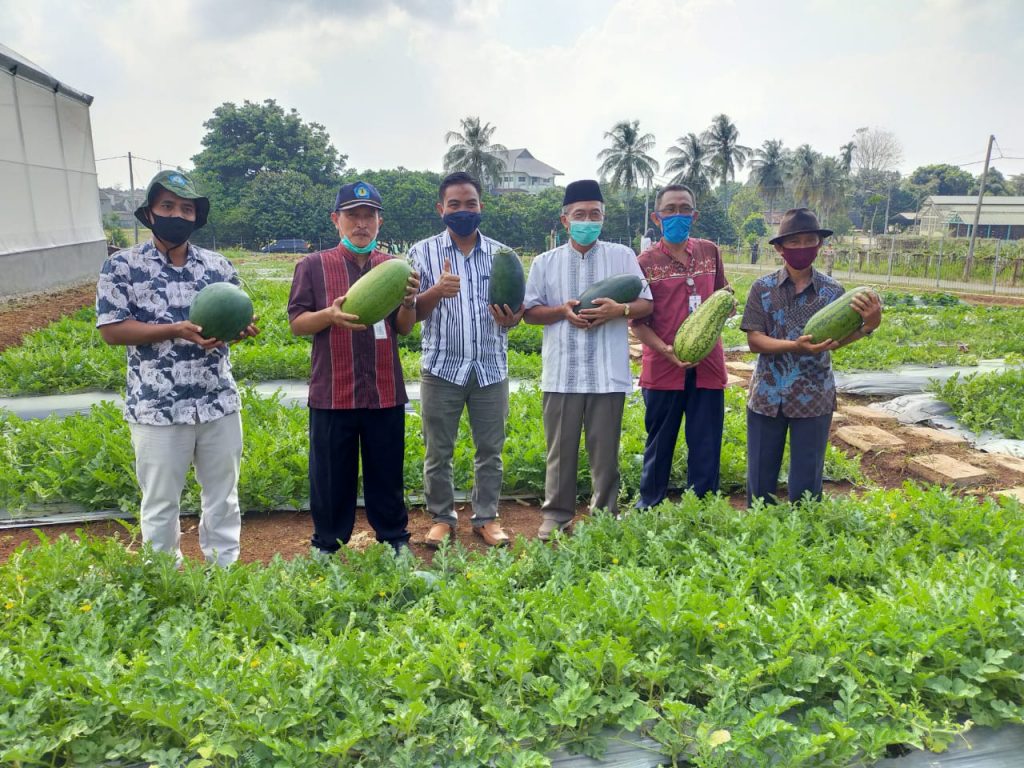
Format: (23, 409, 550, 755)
(96, 171, 258, 565)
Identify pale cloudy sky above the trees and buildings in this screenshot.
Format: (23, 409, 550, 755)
(0, 0, 1024, 185)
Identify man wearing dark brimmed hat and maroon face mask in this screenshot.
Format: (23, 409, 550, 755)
(740, 208, 882, 505)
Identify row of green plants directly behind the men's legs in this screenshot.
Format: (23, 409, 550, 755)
(0, 389, 864, 518)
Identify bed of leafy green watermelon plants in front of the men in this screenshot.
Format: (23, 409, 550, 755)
(0, 485, 1024, 768)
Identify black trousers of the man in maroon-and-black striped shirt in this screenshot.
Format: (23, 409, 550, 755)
(309, 406, 409, 552)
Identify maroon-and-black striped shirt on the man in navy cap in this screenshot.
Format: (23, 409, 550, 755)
(288, 245, 409, 409)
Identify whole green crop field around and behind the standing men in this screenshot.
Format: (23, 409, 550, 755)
(0, 253, 1024, 768)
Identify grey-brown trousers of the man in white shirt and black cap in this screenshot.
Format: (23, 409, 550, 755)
(541, 392, 626, 523)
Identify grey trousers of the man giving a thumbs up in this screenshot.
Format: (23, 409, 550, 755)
(420, 372, 509, 525)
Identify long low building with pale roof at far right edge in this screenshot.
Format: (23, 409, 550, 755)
(916, 195, 1024, 240)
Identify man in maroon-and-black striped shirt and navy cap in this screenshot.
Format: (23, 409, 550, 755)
(288, 181, 419, 554)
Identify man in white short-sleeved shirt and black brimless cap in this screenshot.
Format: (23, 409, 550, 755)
(523, 179, 652, 540)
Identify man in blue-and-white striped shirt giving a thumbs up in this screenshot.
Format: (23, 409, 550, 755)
(409, 172, 523, 548)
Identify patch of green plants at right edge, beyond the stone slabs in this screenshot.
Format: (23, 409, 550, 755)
(932, 368, 1024, 440)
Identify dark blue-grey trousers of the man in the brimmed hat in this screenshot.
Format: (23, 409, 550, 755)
(746, 409, 831, 506)
